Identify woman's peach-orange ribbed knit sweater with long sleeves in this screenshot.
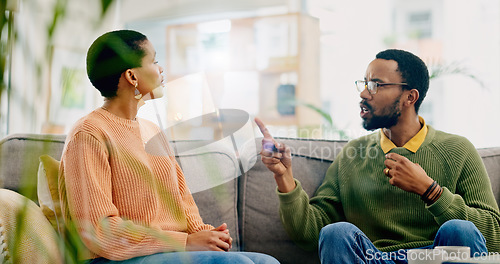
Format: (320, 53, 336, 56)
(59, 108, 213, 260)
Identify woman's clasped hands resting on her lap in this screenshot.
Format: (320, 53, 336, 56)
(186, 223, 233, 251)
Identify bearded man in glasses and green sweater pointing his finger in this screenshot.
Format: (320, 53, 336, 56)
(255, 50, 500, 263)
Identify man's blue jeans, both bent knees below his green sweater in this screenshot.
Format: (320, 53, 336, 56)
(319, 220, 488, 264)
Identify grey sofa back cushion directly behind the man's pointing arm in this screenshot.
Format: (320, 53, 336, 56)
(240, 139, 345, 263)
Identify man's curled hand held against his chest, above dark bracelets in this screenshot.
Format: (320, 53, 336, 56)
(384, 153, 434, 195)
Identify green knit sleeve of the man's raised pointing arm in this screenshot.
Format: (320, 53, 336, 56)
(276, 155, 345, 250)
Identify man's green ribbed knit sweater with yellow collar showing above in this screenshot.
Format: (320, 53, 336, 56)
(278, 126, 500, 252)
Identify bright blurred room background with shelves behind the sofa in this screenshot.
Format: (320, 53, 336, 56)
(0, 0, 500, 148)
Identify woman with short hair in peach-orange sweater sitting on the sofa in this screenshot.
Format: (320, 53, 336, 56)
(59, 30, 278, 263)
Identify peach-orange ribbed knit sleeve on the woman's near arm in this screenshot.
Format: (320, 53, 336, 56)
(61, 132, 187, 260)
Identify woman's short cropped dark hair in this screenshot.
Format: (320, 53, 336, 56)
(87, 30, 147, 98)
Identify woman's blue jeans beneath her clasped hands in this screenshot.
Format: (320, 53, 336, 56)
(88, 251, 279, 264)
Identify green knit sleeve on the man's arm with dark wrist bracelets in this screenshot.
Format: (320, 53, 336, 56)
(427, 140, 500, 252)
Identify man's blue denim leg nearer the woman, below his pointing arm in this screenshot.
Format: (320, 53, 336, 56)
(319, 222, 404, 264)
